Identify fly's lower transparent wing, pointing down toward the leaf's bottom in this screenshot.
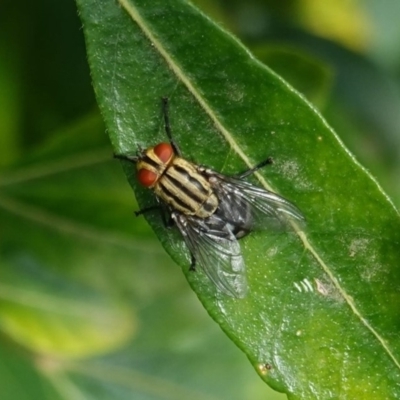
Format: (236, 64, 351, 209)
(172, 213, 247, 298)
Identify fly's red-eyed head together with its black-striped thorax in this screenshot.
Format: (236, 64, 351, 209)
(137, 143, 218, 218)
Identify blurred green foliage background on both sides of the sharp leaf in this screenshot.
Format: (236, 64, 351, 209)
(0, 0, 400, 400)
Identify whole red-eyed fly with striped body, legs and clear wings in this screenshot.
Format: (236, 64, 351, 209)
(115, 98, 303, 298)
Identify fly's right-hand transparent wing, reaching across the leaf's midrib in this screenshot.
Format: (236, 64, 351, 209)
(210, 172, 304, 231)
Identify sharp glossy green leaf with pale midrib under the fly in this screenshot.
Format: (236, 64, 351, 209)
(78, 0, 400, 399)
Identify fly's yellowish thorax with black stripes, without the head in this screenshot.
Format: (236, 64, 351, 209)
(154, 157, 218, 218)
